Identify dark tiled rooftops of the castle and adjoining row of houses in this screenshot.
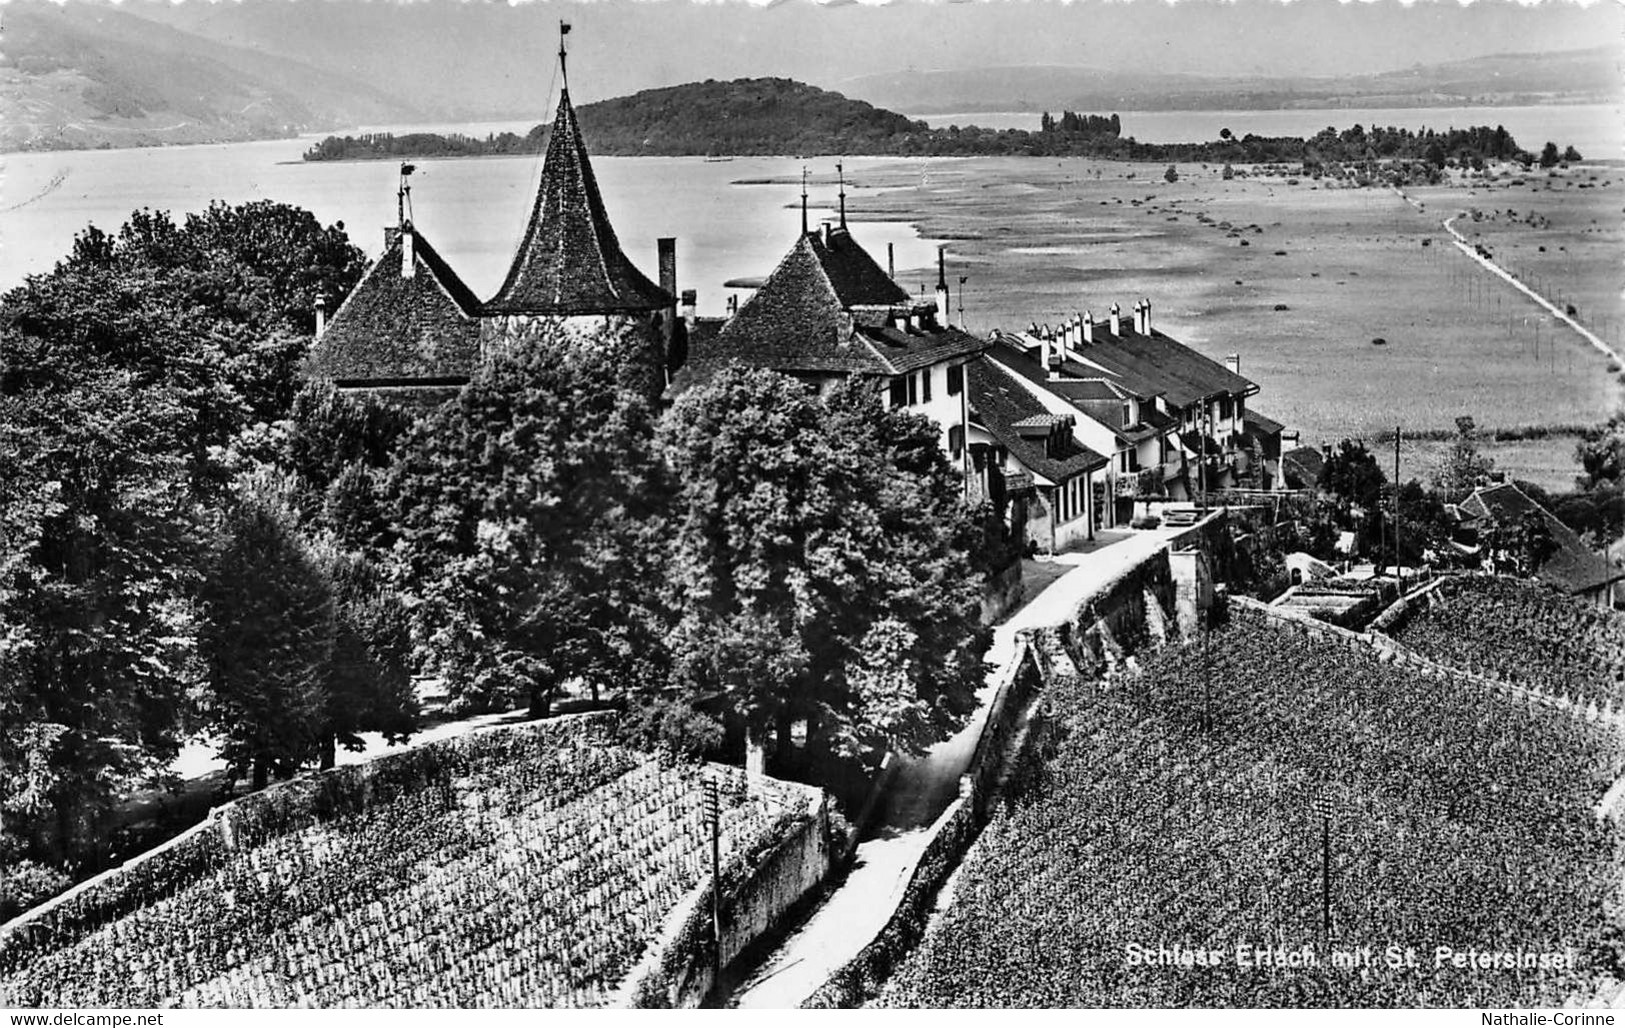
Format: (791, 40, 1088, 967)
(312, 56, 1280, 490)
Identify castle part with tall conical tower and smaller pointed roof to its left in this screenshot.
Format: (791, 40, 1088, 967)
(307, 69, 684, 406)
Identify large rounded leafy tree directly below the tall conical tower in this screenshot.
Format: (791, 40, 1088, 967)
(385, 324, 665, 716)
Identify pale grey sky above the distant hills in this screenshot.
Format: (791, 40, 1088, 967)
(125, 0, 1625, 101)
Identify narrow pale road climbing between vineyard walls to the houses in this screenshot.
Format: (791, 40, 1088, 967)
(733, 531, 1173, 1010)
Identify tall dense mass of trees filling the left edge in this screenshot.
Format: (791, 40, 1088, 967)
(0, 203, 362, 903)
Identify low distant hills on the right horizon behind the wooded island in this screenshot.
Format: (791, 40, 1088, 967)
(837, 47, 1625, 114)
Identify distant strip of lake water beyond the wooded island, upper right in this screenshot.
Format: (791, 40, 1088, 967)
(908, 104, 1625, 158)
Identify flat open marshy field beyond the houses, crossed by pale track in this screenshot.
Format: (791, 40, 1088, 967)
(853, 158, 1625, 484)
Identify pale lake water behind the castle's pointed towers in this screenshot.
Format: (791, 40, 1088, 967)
(0, 135, 936, 315)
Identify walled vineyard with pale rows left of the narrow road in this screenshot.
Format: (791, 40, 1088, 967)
(0, 717, 806, 1007)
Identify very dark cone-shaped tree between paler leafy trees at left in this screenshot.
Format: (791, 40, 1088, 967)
(198, 468, 336, 789)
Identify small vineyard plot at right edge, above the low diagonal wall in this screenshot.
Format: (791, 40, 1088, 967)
(1393, 577, 1625, 710)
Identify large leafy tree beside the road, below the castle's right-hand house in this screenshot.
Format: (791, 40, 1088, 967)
(661, 369, 986, 767)
